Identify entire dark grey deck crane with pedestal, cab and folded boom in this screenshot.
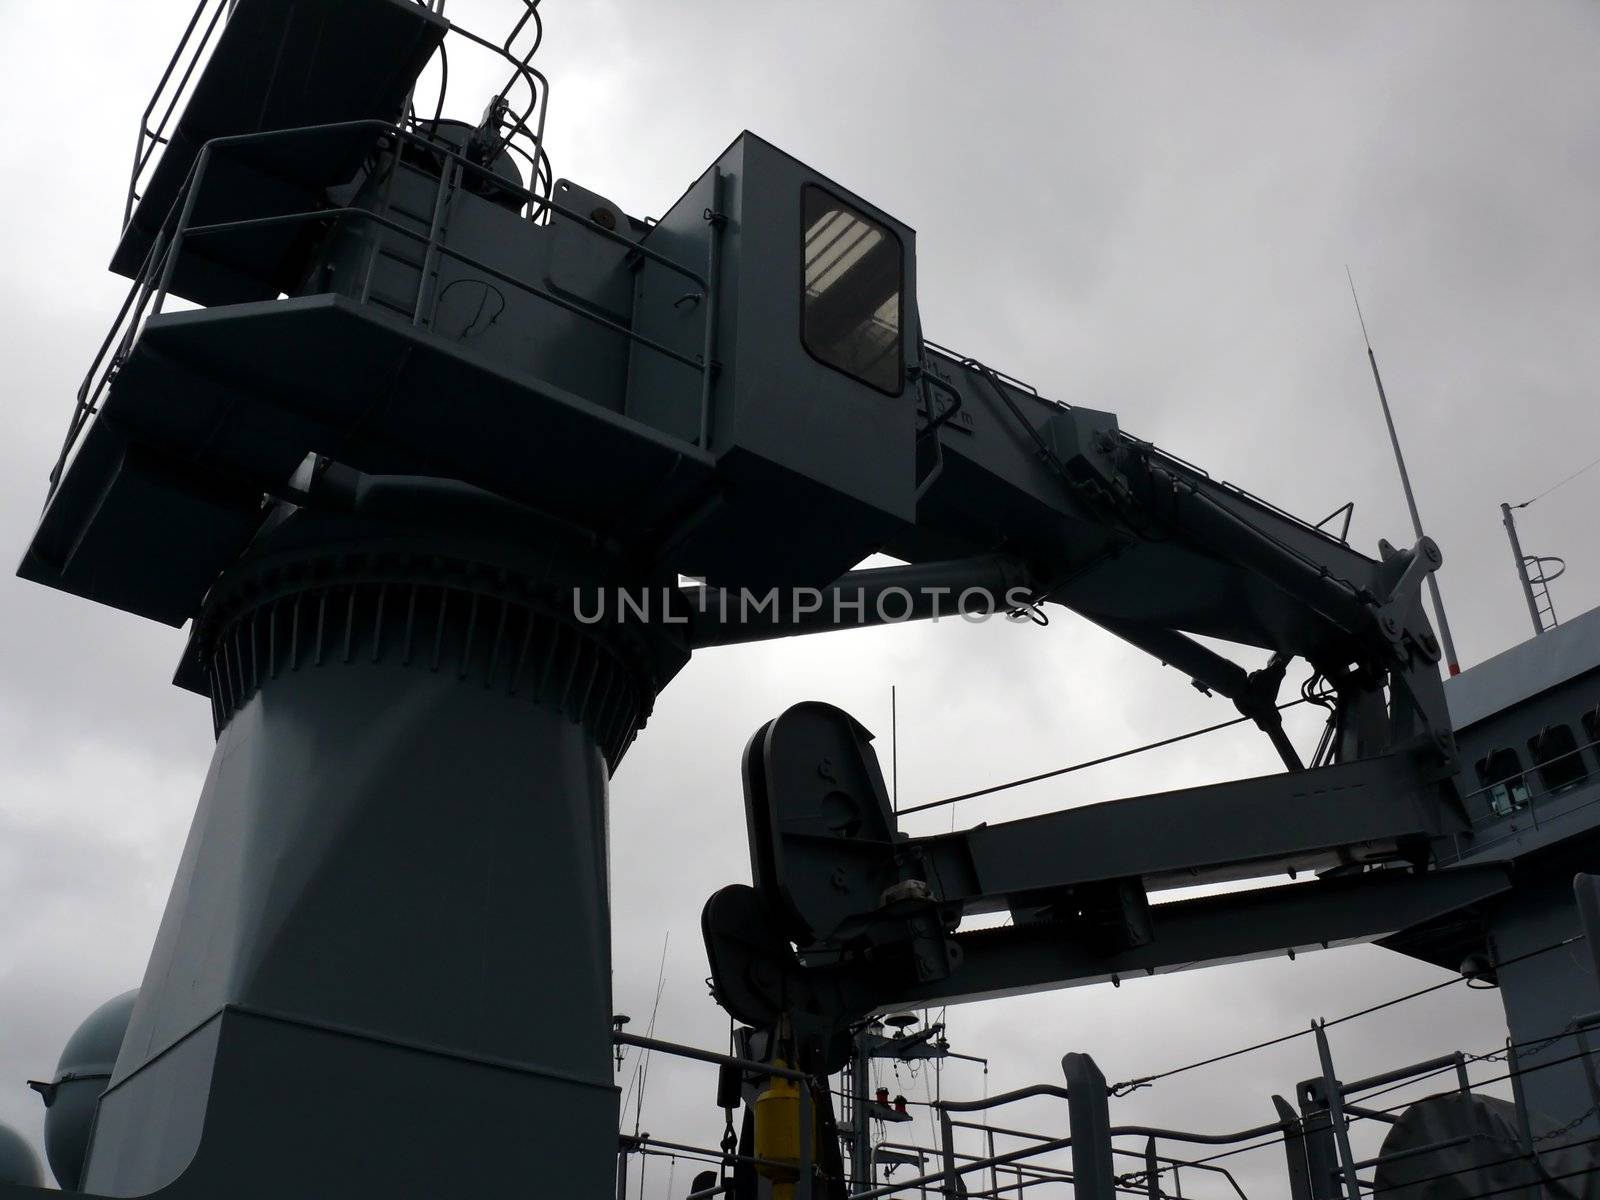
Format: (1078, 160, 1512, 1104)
(9, 0, 1587, 1200)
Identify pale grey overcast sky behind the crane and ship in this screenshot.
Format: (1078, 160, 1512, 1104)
(0, 0, 1600, 1200)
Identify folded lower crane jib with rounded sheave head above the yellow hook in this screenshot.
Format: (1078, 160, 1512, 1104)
(702, 704, 1510, 1066)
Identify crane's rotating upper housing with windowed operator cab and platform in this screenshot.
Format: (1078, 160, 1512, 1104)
(22, 98, 930, 624)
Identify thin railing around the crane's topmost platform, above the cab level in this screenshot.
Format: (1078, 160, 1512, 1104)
(122, 0, 555, 240)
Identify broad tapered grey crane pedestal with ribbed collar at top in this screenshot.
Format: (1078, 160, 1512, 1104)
(85, 510, 682, 1197)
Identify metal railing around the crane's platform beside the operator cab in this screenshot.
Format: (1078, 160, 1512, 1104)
(50, 120, 718, 494)
